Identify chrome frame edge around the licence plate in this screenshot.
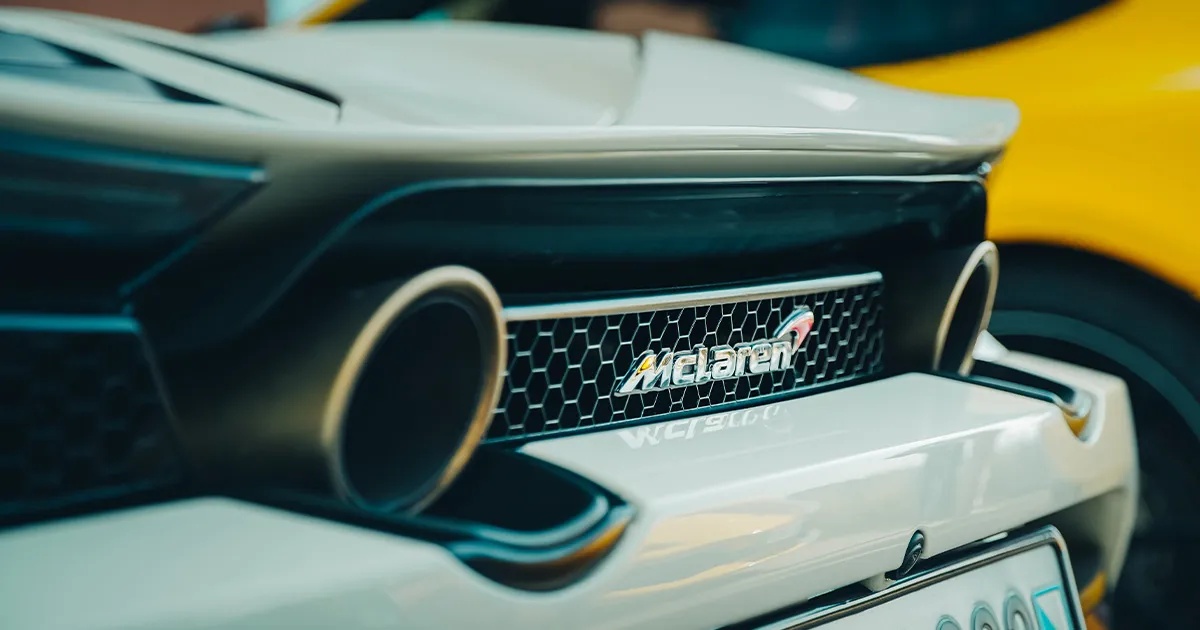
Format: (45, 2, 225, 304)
(755, 526, 1084, 630)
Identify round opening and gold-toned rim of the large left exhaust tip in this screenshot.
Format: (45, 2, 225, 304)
(322, 266, 506, 512)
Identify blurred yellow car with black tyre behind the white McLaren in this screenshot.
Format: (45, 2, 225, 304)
(274, 0, 1200, 628)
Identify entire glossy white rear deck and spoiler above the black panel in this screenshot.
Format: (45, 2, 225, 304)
(0, 8, 1018, 176)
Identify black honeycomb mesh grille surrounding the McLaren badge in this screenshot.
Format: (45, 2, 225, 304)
(488, 274, 883, 442)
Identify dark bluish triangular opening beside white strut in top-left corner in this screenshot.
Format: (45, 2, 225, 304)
(0, 31, 217, 104)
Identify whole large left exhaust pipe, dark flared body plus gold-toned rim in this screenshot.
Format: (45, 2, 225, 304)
(176, 266, 506, 512)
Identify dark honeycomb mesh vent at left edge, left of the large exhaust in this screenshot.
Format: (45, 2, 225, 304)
(0, 321, 181, 515)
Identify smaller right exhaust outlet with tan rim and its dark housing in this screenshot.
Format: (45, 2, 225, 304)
(883, 241, 1000, 376)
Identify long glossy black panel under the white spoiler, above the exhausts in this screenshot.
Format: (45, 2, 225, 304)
(136, 175, 986, 352)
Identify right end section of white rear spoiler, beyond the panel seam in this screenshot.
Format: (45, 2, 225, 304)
(622, 32, 1018, 150)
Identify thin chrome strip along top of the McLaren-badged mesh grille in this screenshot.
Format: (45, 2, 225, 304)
(504, 271, 883, 322)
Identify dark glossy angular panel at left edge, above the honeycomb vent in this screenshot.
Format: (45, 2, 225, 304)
(0, 130, 266, 311)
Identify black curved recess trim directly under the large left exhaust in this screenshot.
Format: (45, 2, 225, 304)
(238, 448, 634, 592)
